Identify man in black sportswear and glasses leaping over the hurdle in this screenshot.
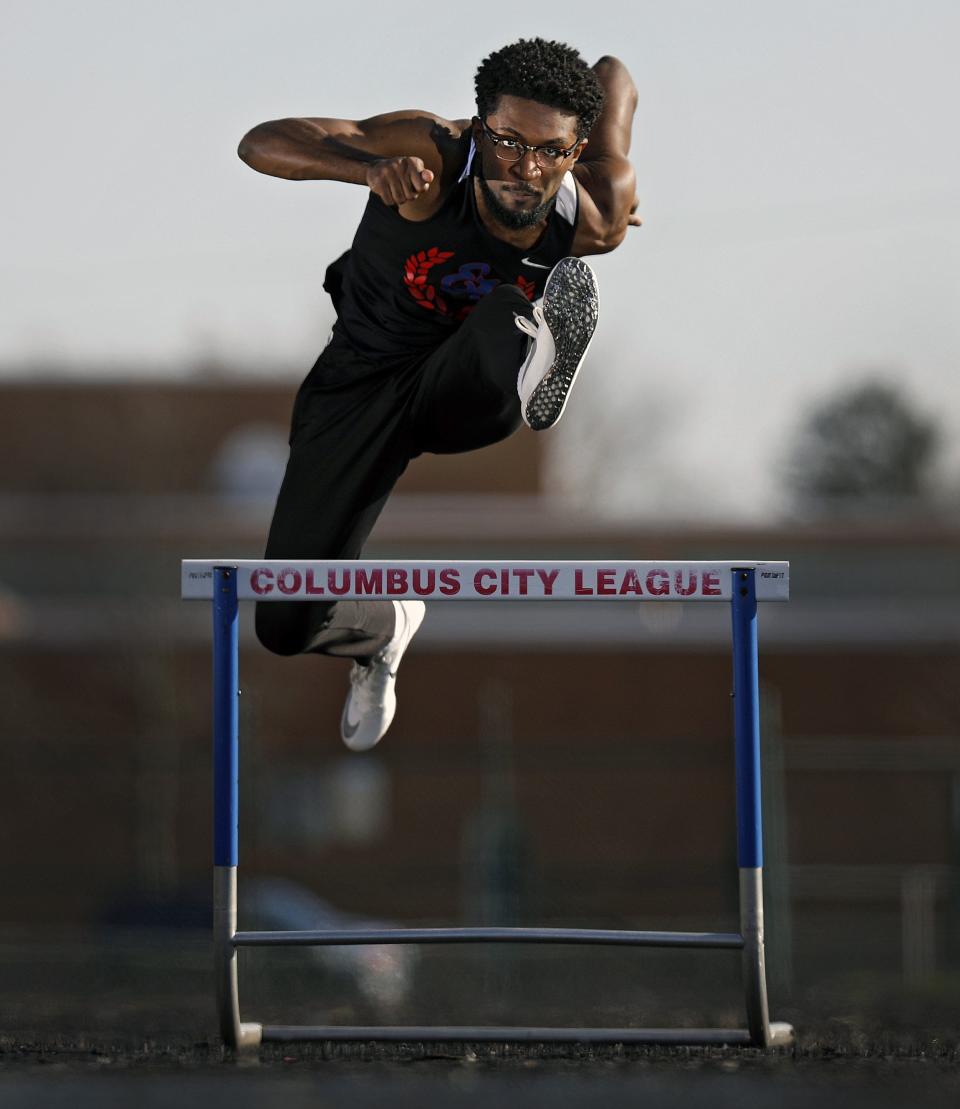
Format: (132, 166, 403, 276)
(238, 39, 640, 751)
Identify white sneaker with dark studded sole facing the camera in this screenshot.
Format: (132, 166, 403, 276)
(515, 258, 600, 431)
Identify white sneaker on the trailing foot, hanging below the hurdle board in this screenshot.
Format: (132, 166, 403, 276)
(340, 601, 427, 751)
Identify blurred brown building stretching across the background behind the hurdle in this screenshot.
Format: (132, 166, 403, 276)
(0, 381, 960, 978)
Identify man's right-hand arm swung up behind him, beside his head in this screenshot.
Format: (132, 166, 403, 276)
(573, 58, 641, 254)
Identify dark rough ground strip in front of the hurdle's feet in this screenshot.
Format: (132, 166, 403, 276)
(0, 1040, 960, 1109)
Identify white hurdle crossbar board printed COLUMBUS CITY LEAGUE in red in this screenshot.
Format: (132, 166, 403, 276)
(181, 559, 790, 601)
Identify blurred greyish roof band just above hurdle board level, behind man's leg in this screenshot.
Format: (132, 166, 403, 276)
(0, 492, 960, 547)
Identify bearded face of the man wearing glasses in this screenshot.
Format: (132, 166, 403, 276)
(473, 95, 583, 230)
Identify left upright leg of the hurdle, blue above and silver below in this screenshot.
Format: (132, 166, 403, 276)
(213, 567, 261, 1048)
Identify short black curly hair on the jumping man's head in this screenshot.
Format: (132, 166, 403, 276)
(476, 39, 603, 139)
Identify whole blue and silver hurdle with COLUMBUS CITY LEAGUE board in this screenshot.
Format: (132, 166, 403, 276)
(181, 559, 794, 1049)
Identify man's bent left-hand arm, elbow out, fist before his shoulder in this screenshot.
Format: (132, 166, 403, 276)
(237, 111, 460, 206)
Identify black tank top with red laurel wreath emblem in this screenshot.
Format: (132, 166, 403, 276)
(324, 141, 579, 369)
